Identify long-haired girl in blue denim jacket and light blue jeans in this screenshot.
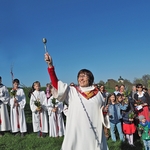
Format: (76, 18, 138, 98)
(108, 93, 128, 142)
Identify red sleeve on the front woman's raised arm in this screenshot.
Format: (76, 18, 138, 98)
(48, 66, 58, 90)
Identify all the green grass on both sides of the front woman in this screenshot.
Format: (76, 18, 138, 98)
(0, 89, 144, 150)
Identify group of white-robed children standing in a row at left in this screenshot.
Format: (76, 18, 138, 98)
(0, 77, 65, 137)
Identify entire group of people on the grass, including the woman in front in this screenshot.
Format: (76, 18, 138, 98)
(0, 53, 150, 150)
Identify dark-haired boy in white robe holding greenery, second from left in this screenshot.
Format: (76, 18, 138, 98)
(10, 79, 27, 137)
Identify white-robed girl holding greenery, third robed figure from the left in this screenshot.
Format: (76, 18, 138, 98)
(30, 81, 48, 137)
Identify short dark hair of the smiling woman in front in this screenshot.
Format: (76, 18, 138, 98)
(77, 69, 94, 86)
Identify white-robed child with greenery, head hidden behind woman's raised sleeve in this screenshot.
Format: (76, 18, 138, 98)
(47, 96, 65, 137)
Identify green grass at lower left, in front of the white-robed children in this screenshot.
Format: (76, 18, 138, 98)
(0, 133, 63, 150)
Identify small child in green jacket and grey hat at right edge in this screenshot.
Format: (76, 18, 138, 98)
(138, 115, 150, 150)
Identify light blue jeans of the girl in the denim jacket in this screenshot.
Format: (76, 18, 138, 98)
(110, 122, 125, 142)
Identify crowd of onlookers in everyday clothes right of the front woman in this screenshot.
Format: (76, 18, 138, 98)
(95, 84, 150, 150)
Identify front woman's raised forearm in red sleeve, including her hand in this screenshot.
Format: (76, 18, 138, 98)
(45, 53, 58, 89)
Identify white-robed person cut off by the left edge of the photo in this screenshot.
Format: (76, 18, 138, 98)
(0, 77, 11, 136)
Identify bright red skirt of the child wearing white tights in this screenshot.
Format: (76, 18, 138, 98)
(122, 123, 136, 134)
